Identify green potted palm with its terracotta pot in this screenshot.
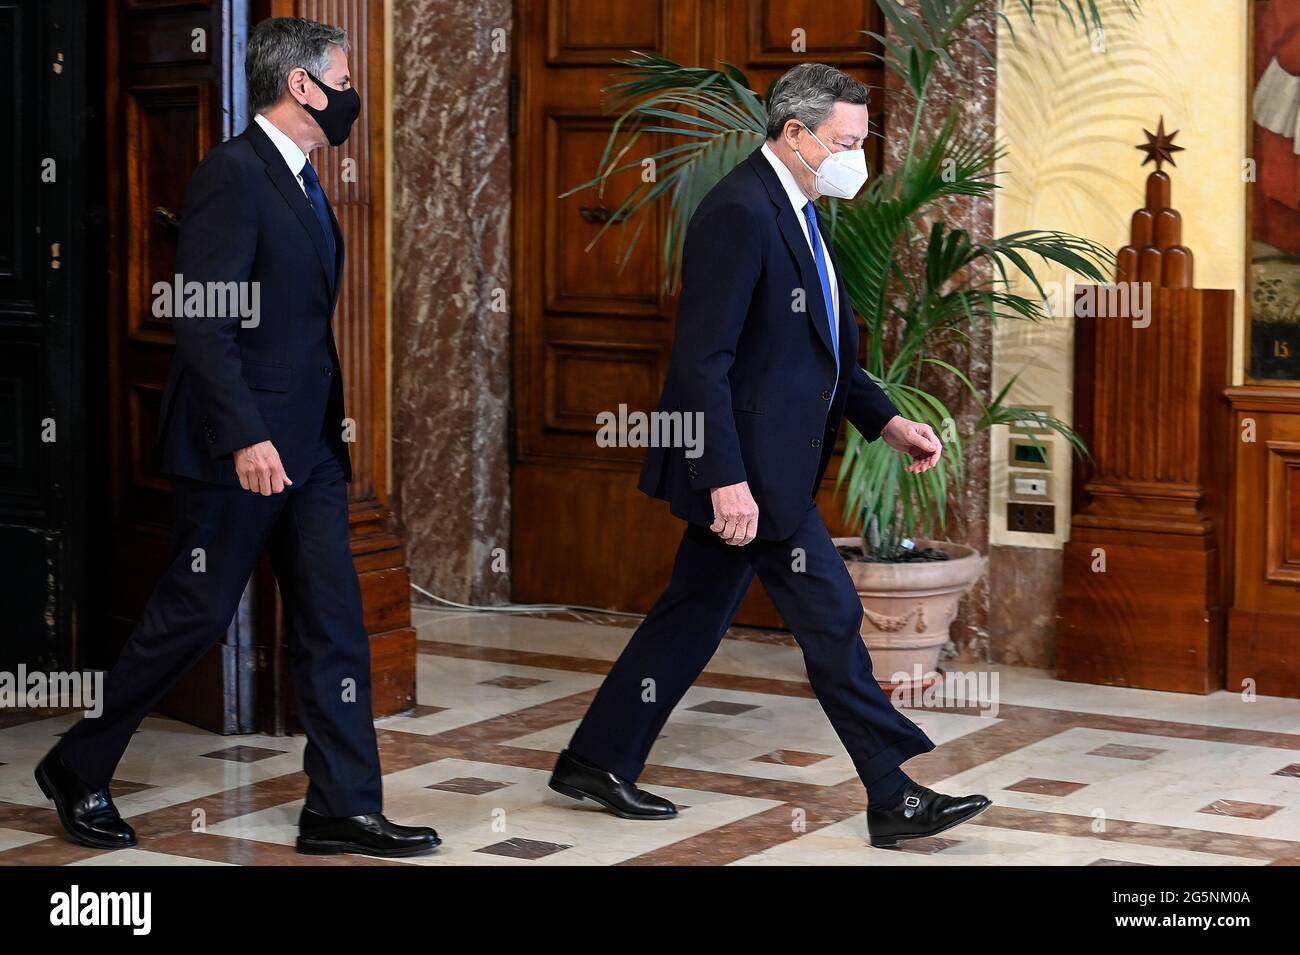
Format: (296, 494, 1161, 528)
(566, 0, 1138, 683)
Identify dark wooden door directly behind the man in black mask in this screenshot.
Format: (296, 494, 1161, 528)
(94, 0, 255, 733)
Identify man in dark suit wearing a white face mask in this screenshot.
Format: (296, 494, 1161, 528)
(551, 64, 989, 846)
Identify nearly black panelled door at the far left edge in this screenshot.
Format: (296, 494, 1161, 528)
(0, 0, 101, 672)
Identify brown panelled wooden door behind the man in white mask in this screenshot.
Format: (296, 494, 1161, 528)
(511, 0, 881, 626)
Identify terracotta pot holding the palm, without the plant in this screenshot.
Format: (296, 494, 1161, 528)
(835, 537, 985, 687)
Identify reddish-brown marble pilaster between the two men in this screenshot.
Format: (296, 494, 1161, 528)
(391, 0, 512, 603)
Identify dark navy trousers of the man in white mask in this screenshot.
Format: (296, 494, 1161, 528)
(569, 504, 935, 785)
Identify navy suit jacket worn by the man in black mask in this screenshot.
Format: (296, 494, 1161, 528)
(157, 122, 351, 485)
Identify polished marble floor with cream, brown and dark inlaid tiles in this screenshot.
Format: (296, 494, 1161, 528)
(0, 608, 1300, 867)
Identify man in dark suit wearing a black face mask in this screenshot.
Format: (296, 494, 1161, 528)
(36, 18, 438, 856)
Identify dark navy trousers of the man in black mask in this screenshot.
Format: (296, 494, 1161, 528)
(56, 442, 382, 816)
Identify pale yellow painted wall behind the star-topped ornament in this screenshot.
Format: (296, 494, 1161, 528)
(989, 0, 1248, 547)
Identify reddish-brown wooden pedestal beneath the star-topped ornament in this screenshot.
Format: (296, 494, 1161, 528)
(1057, 280, 1232, 693)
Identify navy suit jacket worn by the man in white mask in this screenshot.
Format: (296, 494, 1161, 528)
(640, 149, 898, 541)
